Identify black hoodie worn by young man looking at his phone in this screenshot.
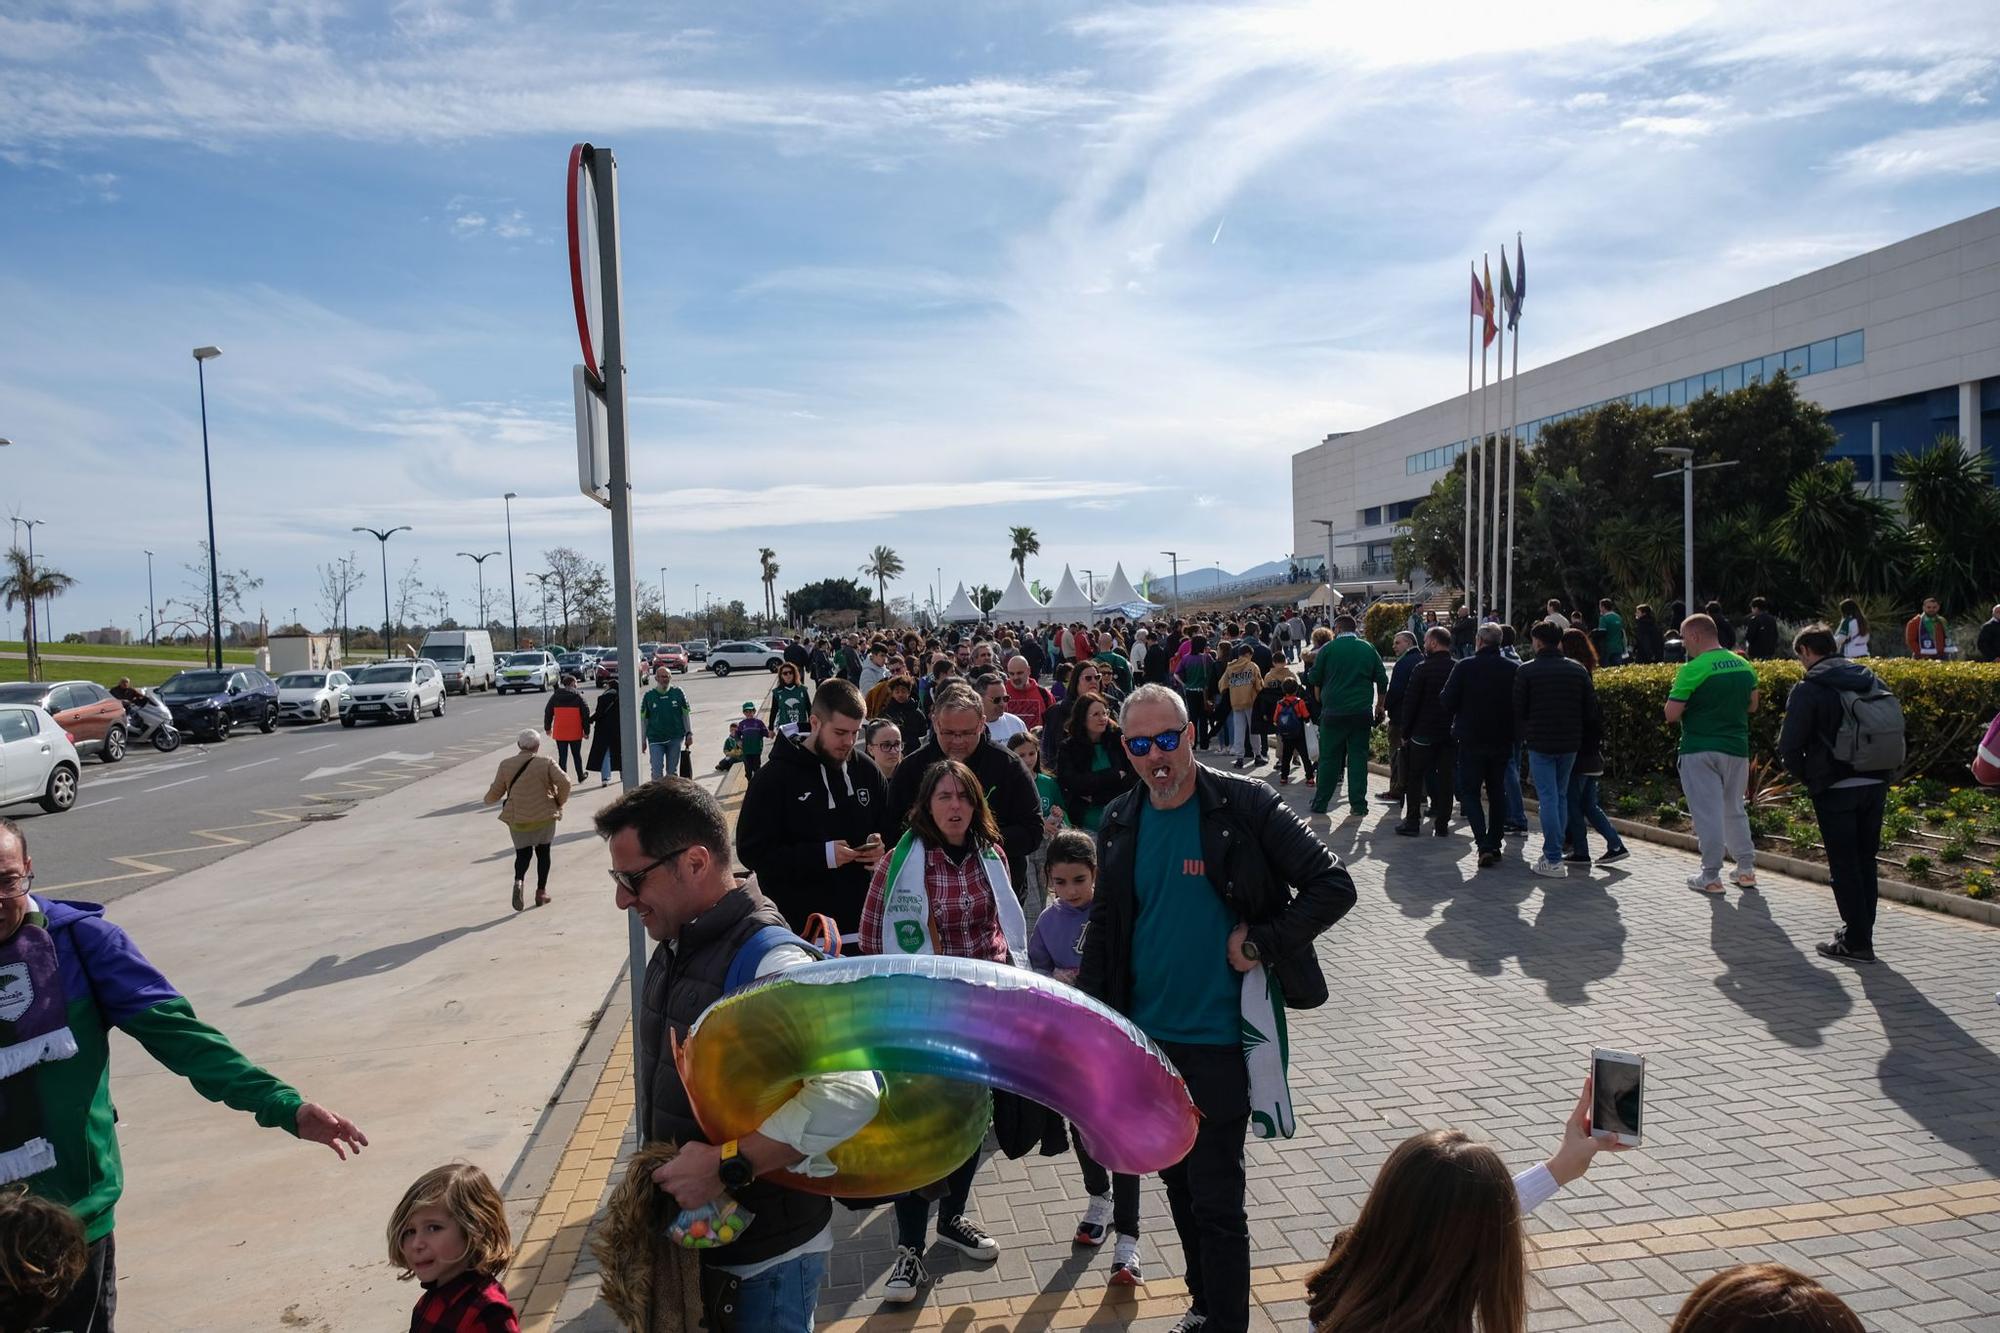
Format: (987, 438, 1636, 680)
(736, 731, 900, 935)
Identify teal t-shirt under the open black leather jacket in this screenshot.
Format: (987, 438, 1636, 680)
(1132, 799, 1242, 1047)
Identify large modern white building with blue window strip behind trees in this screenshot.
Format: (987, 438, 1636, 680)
(1292, 208, 2000, 582)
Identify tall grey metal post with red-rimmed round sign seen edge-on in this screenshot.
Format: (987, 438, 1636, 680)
(568, 144, 650, 1112)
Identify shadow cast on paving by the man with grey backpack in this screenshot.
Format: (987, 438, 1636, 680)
(1854, 963, 2000, 1175)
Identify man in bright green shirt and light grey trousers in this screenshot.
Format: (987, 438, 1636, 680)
(1666, 614, 1758, 893)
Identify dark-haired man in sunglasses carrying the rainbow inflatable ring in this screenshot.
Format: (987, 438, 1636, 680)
(596, 772, 878, 1333)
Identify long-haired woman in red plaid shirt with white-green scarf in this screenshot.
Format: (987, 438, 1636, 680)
(860, 759, 1012, 1301)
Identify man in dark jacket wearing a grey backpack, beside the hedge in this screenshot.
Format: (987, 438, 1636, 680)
(1778, 624, 1888, 963)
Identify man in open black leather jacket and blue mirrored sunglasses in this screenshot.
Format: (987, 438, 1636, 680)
(1076, 685, 1354, 1333)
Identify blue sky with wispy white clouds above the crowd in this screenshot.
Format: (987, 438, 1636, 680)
(0, 0, 2000, 634)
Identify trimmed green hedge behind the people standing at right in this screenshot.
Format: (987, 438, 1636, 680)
(1596, 658, 2000, 785)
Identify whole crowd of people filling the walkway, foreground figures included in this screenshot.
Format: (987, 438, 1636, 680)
(0, 602, 1912, 1333)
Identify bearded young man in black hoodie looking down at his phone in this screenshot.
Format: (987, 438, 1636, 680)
(736, 681, 900, 941)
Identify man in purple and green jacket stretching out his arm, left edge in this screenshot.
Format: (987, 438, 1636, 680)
(0, 819, 368, 1333)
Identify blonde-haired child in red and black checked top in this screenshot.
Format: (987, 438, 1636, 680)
(388, 1161, 520, 1333)
